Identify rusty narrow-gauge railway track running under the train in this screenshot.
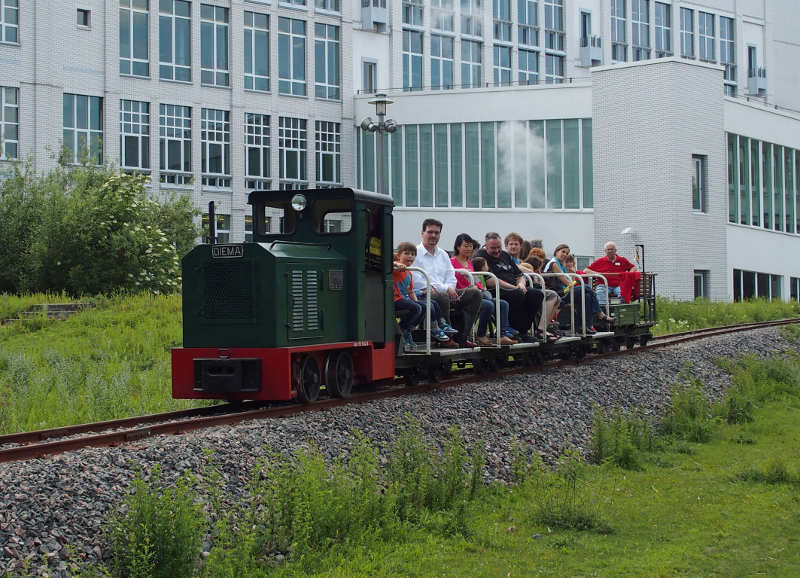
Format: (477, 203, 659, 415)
(0, 319, 800, 462)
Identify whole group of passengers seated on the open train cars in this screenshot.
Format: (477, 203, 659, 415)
(394, 219, 636, 350)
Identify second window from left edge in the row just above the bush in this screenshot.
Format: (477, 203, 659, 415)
(63, 93, 103, 165)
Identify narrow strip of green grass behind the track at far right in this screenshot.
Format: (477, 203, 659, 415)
(652, 298, 800, 335)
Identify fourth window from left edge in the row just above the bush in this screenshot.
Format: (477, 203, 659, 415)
(158, 104, 192, 185)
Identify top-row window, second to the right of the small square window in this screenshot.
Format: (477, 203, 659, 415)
(158, 0, 192, 82)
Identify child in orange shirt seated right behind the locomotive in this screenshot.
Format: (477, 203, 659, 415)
(392, 243, 455, 351)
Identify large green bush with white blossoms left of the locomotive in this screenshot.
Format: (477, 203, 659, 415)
(0, 161, 198, 295)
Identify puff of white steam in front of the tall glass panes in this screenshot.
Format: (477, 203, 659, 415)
(497, 121, 545, 207)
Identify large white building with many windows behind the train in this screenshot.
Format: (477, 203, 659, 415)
(0, 0, 800, 300)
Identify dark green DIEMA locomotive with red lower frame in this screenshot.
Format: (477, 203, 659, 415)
(173, 189, 394, 399)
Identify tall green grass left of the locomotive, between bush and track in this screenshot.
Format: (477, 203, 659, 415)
(0, 295, 211, 433)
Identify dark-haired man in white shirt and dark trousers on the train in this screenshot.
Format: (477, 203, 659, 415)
(413, 219, 481, 347)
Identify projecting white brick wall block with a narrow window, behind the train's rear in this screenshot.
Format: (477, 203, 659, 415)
(592, 58, 728, 299)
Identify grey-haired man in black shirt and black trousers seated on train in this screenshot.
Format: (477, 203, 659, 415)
(477, 233, 544, 341)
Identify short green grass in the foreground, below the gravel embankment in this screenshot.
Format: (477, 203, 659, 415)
(282, 382, 800, 576)
